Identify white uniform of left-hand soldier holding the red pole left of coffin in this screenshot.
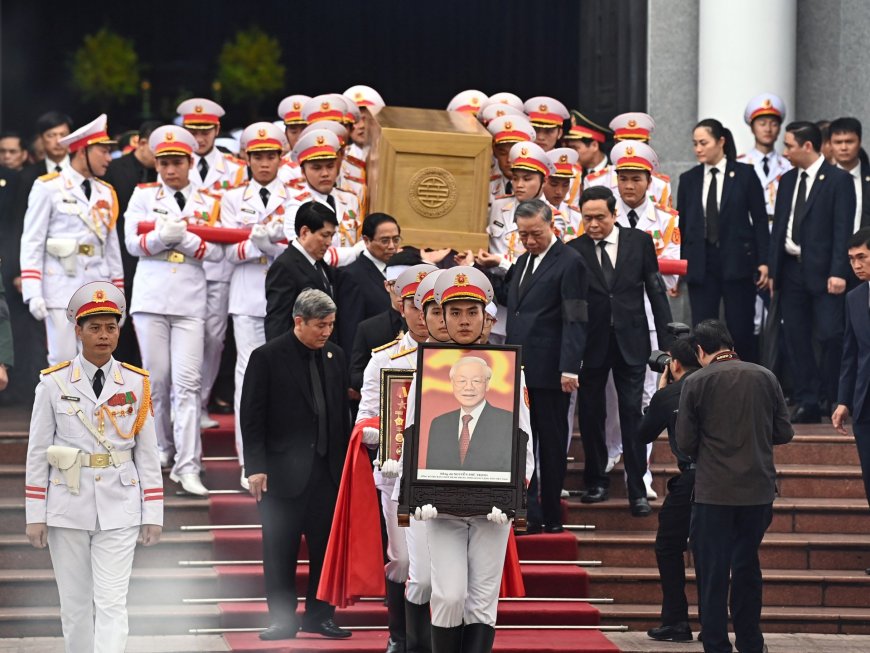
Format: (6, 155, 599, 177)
(124, 181, 223, 476)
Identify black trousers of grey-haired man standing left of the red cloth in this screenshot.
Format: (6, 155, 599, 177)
(259, 456, 338, 626)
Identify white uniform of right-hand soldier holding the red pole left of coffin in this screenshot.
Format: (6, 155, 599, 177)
(221, 178, 291, 467)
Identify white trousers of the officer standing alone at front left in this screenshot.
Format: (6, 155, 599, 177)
(48, 526, 139, 653)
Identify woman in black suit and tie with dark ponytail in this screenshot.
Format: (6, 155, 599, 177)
(677, 118, 770, 361)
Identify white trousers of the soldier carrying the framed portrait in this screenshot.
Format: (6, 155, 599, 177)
(425, 515, 512, 628)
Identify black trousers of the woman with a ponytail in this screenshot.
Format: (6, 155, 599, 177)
(688, 243, 758, 363)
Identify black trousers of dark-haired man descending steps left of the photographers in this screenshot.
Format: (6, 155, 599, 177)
(580, 329, 646, 501)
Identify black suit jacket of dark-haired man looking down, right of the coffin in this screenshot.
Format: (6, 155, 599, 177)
(568, 225, 671, 367)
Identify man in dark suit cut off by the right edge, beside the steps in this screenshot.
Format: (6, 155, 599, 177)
(831, 227, 870, 512)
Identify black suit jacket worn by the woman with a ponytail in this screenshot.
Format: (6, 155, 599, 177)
(677, 161, 770, 283)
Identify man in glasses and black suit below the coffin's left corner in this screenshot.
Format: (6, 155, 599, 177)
(336, 213, 402, 358)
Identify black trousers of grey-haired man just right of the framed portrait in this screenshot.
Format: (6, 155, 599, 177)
(528, 388, 571, 526)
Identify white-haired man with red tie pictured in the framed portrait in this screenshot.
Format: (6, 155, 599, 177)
(426, 356, 514, 472)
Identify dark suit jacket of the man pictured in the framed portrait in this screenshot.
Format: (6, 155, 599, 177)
(426, 402, 514, 472)
